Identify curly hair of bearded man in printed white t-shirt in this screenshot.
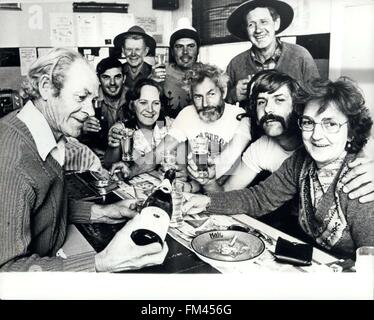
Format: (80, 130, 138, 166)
(183, 63, 229, 96)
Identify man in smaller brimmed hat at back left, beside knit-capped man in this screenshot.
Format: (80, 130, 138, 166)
(113, 26, 156, 89)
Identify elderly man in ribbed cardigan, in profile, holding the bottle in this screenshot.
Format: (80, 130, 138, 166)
(0, 48, 168, 271)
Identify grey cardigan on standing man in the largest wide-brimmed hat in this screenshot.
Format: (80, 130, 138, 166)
(226, 42, 319, 104)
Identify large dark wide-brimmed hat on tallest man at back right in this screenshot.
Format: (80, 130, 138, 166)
(226, 0, 294, 40)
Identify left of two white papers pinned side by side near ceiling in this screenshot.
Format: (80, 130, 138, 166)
(49, 13, 75, 47)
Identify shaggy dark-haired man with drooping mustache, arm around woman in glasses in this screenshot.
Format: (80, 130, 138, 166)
(188, 70, 374, 202)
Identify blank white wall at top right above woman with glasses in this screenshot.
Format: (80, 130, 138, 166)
(330, 0, 374, 119)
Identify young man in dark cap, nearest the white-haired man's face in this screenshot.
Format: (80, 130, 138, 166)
(80, 57, 128, 150)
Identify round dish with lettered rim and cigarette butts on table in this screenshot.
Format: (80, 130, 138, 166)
(191, 230, 265, 264)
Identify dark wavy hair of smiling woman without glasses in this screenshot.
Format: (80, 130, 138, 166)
(122, 79, 166, 129)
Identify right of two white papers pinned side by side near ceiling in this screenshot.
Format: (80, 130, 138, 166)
(76, 13, 101, 47)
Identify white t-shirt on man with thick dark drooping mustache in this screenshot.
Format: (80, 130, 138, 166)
(242, 135, 295, 173)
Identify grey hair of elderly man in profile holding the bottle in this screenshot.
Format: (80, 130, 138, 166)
(22, 48, 85, 101)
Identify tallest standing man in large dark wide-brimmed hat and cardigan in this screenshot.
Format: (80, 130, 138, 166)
(226, 0, 319, 103)
